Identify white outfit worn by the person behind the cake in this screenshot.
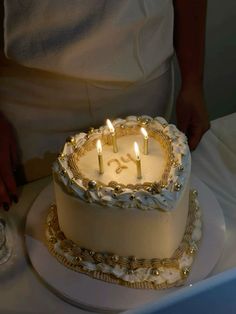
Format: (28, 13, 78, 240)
(0, 0, 173, 179)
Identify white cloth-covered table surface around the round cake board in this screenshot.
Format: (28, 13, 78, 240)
(0, 113, 236, 314)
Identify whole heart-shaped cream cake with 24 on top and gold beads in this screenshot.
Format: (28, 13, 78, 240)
(46, 116, 201, 289)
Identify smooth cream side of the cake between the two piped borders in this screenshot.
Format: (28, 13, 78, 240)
(54, 173, 189, 258)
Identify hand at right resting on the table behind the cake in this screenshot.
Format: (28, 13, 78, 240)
(176, 86, 210, 150)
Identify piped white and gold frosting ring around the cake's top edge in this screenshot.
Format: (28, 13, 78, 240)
(53, 116, 191, 211)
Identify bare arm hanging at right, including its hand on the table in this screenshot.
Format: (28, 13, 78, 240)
(173, 0, 209, 150)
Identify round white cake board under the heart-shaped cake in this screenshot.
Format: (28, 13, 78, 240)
(25, 177, 225, 313)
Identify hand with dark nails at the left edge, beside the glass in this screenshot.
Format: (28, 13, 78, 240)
(0, 113, 18, 210)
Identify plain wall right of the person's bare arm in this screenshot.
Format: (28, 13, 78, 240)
(205, 0, 236, 118)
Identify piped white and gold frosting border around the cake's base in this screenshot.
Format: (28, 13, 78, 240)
(46, 190, 202, 289)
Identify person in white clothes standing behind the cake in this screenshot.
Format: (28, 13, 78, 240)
(0, 0, 209, 210)
